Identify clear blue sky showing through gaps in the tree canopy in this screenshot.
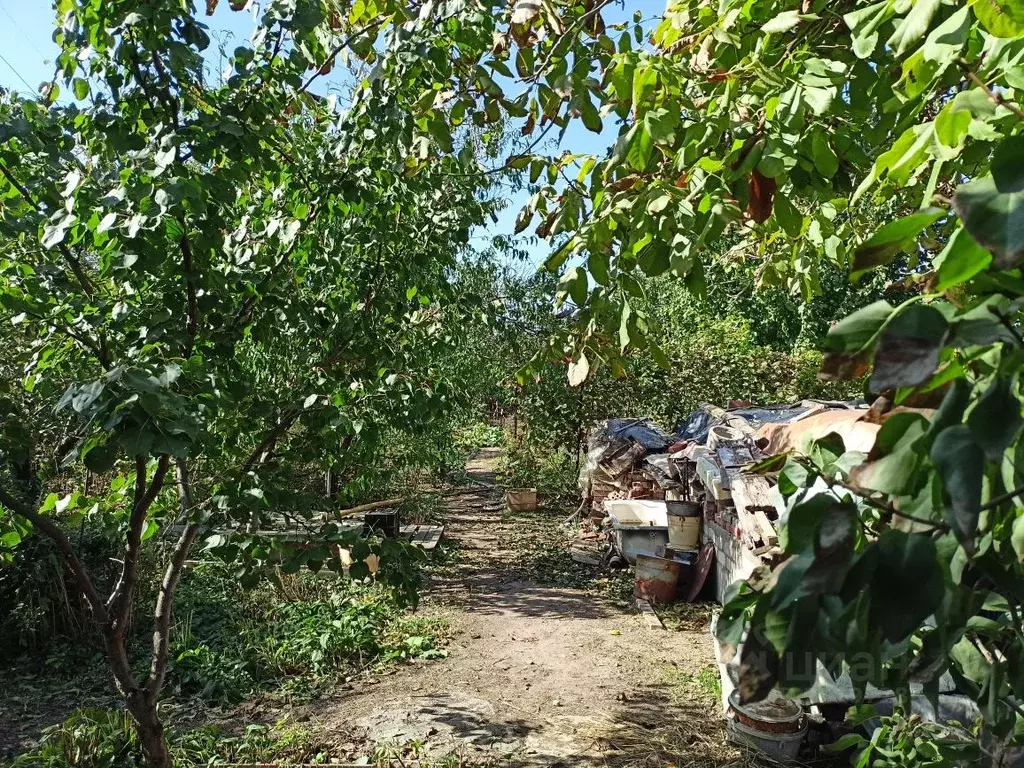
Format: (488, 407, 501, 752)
(0, 0, 665, 272)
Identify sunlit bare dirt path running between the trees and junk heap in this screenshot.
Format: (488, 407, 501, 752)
(316, 450, 716, 766)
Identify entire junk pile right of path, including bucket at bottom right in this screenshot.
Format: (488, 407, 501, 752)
(573, 400, 991, 762)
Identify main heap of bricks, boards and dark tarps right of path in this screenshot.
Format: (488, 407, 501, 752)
(575, 400, 873, 603)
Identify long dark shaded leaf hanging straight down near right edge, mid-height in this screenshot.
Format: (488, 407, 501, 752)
(931, 424, 985, 553)
